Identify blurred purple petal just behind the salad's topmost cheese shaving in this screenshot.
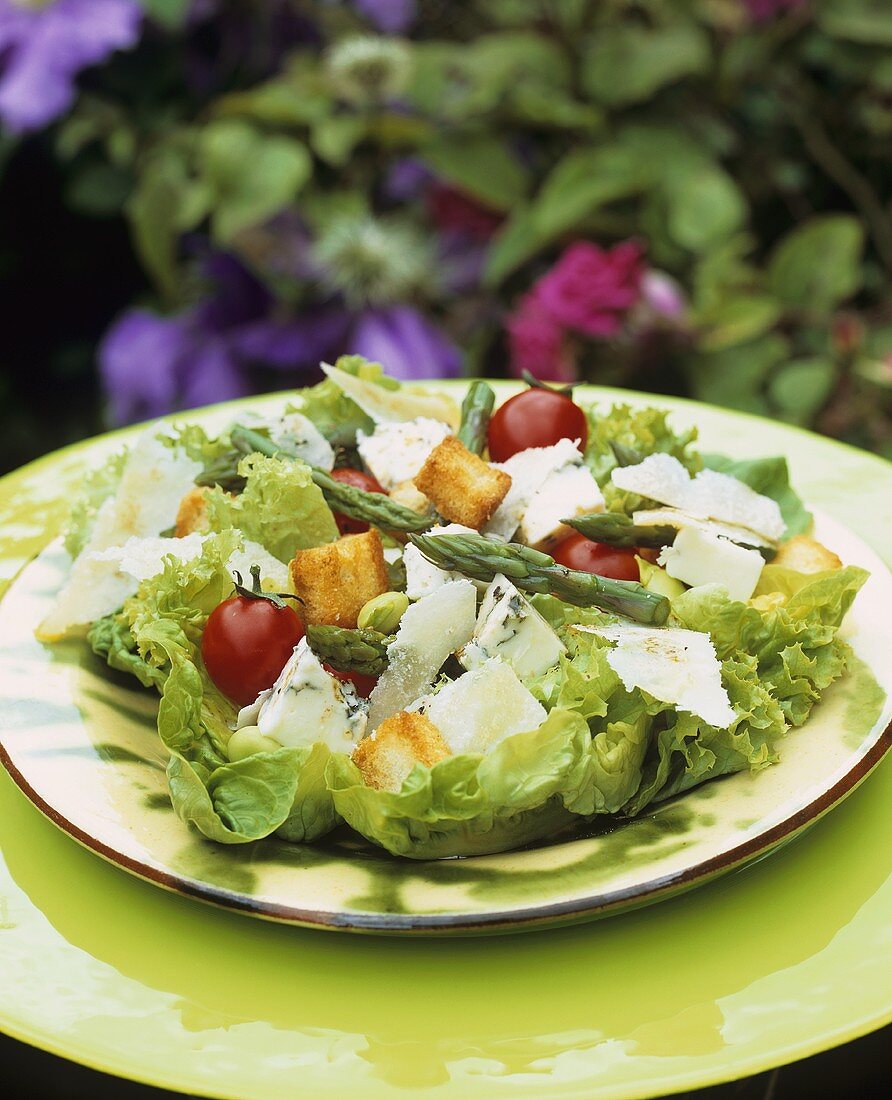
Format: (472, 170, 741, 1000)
(349, 306, 462, 378)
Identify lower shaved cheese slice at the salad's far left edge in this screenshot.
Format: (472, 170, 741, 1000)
(37, 534, 207, 641)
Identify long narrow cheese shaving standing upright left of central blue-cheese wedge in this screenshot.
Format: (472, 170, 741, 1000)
(368, 580, 477, 729)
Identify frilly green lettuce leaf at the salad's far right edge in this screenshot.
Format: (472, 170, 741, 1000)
(672, 565, 868, 726)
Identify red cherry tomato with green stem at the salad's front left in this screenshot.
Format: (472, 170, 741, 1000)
(201, 595, 306, 706)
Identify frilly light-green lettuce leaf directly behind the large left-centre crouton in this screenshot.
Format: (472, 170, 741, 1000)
(207, 454, 338, 562)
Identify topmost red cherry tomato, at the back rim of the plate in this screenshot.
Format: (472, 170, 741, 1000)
(487, 386, 588, 462)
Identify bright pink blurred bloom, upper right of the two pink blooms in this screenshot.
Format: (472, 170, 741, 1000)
(532, 241, 643, 337)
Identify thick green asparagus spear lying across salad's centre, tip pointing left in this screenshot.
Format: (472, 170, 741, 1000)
(409, 535, 669, 626)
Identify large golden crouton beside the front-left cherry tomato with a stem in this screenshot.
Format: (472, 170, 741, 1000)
(290, 527, 390, 627)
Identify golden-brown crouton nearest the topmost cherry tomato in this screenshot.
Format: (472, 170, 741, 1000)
(415, 436, 511, 528)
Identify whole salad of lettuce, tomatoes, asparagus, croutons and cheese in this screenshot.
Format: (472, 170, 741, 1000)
(37, 356, 867, 859)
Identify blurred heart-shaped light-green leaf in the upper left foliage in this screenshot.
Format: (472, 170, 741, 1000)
(199, 119, 312, 243)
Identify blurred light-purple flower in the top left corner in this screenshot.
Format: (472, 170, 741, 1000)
(0, 0, 142, 133)
